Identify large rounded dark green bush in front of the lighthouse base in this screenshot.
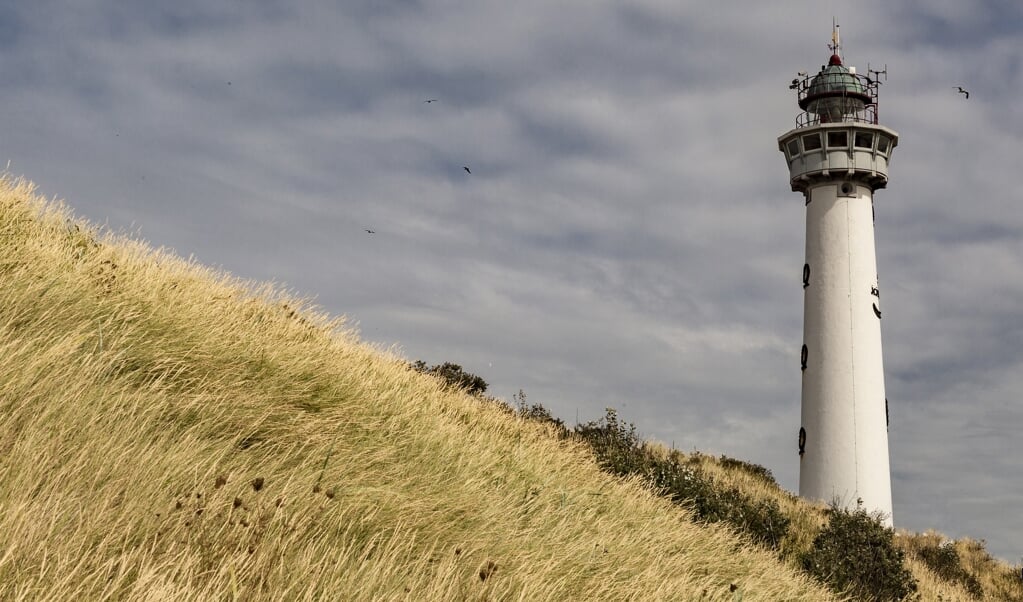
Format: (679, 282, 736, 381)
(800, 506, 917, 602)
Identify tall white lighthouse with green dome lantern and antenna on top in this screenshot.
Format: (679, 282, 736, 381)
(777, 27, 898, 526)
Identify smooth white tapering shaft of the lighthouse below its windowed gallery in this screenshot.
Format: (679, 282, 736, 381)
(799, 180, 892, 524)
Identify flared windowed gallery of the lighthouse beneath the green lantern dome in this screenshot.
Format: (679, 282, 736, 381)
(777, 122, 898, 191)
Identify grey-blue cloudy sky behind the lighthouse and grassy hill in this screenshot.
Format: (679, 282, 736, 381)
(0, 0, 1023, 562)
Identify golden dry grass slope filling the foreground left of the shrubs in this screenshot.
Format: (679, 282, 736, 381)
(0, 179, 832, 601)
